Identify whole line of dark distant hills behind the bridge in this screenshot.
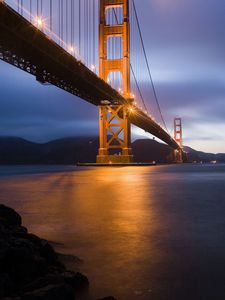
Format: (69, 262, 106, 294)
(0, 137, 225, 164)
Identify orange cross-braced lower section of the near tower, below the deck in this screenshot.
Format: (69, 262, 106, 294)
(97, 105, 133, 164)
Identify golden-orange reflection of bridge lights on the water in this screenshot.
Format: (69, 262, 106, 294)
(0, 167, 158, 297)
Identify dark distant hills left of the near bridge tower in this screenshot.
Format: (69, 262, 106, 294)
(0, 137, 98, 164)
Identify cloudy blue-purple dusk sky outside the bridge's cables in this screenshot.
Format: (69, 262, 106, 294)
(0, 0, 225, 153)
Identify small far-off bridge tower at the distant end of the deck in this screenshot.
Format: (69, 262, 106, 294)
(174, 118, 183, 163)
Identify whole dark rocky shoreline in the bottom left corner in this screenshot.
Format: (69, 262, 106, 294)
(0, 205, 115, 300)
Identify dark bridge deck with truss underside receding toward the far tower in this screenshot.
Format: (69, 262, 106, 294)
(0, 2, 179, 149)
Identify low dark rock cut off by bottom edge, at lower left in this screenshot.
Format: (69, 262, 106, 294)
(21, 284, 74, 300)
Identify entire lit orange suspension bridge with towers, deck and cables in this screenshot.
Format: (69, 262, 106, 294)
(0, 0, 184, 164)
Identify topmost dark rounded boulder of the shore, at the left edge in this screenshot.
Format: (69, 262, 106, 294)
(0, 204, 22, 226)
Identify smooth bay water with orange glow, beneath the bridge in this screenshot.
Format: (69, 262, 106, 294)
(0, 165, 225, 300)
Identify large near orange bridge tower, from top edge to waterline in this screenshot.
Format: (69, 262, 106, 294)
(97, 0, 133, 163)
